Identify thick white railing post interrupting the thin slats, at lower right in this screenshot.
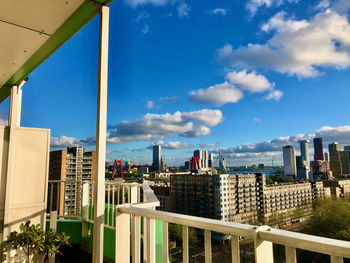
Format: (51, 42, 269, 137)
(254, 226, 273, 263)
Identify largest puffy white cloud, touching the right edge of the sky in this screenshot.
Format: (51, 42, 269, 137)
(218, 9, 350, 77)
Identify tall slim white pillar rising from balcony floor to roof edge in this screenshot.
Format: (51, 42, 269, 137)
(92, 6, 109, 263)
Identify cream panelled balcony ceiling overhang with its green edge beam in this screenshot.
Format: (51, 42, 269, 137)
(0, 0, 112, 102)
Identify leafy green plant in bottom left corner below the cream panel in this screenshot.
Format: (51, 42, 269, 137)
(7, 221, 69, 262)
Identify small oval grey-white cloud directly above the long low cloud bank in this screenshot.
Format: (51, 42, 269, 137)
(189, 81, 243, 106)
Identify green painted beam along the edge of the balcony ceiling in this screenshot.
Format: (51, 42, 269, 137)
(0, 0, 112, 103)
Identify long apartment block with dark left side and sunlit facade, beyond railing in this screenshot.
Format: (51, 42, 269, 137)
(170, 174, 330, 229)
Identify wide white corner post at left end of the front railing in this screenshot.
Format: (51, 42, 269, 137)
(115, 205, 130, 263)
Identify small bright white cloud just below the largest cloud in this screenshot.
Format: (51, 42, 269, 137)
(226, 70, 275, 92)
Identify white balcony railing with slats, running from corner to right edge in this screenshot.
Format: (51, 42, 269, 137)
(47, 182, 350, 263)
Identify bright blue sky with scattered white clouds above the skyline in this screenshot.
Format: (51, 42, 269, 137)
(0, 0, 350, 165)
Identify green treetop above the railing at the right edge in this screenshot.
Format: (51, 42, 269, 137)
(304, 199, 350, 241)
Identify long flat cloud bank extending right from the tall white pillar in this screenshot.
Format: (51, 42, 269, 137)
(107, 109, 223, 143)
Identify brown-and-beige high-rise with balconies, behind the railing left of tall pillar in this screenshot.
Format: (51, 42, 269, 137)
(48, 147, 96, 215)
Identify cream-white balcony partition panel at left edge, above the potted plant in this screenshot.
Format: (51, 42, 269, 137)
(0, 127, 50, 240)
